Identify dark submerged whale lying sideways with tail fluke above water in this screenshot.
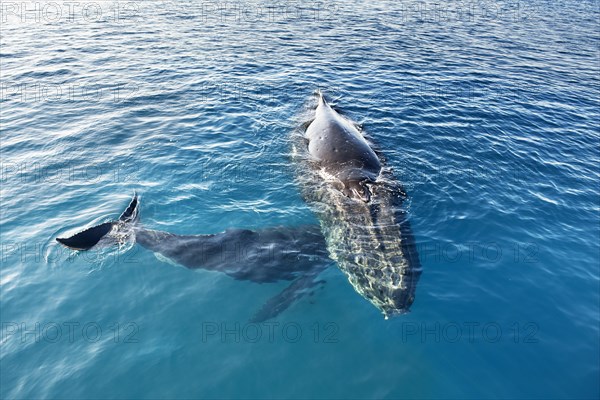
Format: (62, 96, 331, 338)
(56, 195, 332, 322)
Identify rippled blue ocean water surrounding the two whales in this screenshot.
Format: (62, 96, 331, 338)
(0, 0, 600, 399)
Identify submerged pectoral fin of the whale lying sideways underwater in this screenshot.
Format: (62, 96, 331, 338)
(250, 266, 327, 323)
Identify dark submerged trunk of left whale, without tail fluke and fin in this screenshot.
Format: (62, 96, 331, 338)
(135, 225, 330, 283)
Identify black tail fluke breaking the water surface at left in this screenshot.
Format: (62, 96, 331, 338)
(56, 193, 140, 250)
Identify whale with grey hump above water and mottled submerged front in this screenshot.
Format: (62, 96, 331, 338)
(292, 92, 421, 318)
